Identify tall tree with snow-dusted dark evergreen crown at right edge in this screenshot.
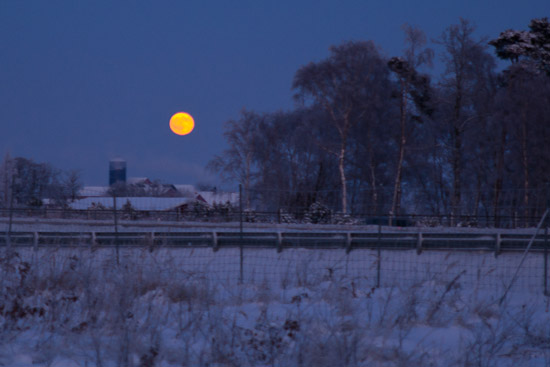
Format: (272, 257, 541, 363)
(489, 18, 550, 224)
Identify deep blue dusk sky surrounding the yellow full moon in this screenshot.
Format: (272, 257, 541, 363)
(0, 0, 550, 185)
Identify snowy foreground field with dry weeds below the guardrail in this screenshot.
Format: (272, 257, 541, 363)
(0, 242, 550, 367)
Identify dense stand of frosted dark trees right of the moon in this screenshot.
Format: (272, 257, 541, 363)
(208, 18, 550, 224)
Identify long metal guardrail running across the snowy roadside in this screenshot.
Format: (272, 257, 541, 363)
(0, 231, 550, 255)
